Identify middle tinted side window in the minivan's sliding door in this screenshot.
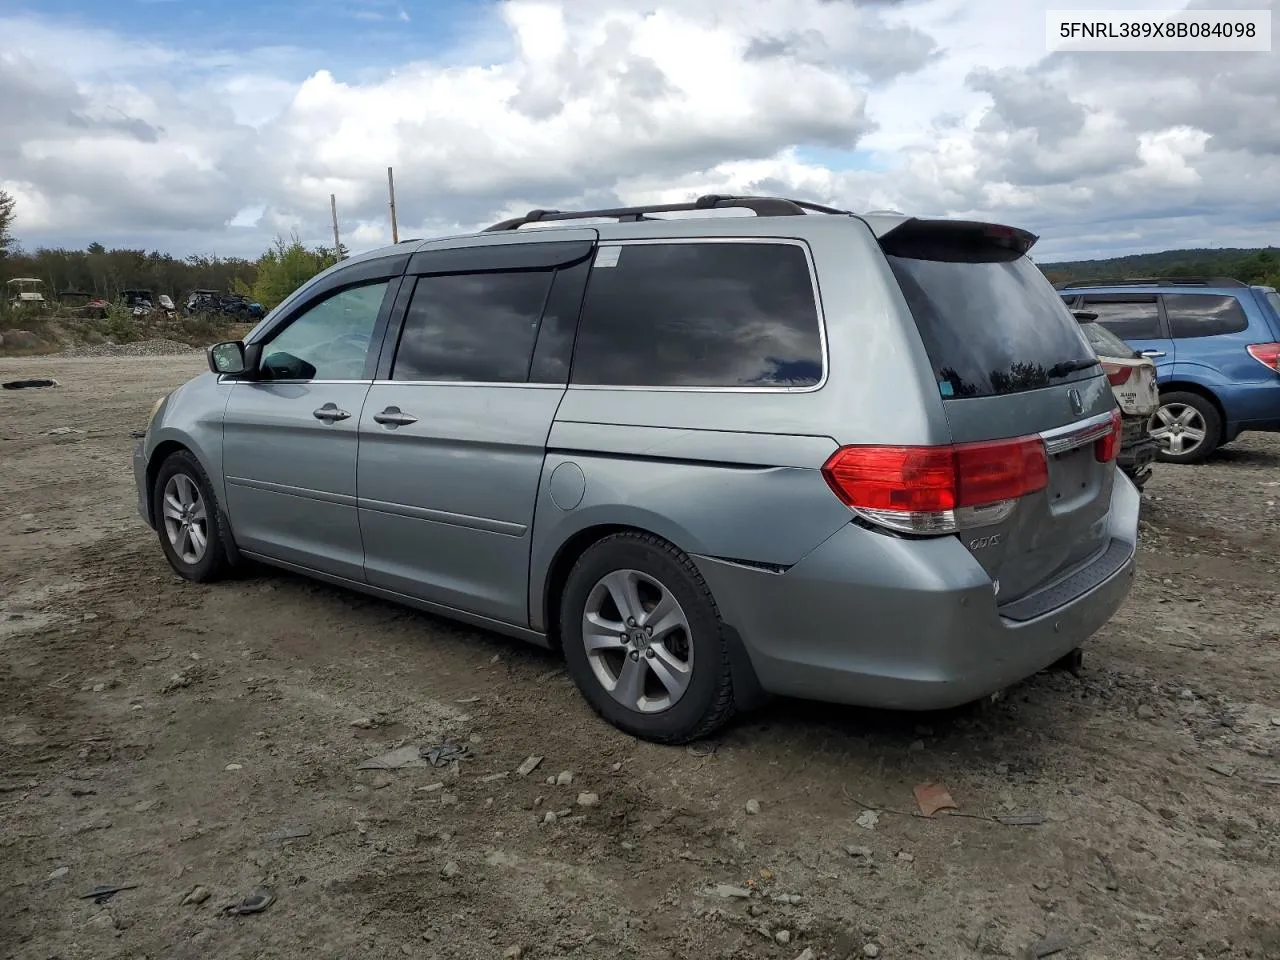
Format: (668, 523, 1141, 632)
(392, 270, 552, 383)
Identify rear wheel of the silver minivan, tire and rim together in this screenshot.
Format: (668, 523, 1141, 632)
(559, 532, 733, 744)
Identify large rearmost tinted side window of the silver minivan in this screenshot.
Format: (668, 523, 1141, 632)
(572, 241, 823, 387)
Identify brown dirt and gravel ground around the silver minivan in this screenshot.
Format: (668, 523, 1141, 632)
(0, 355, 1280, 960)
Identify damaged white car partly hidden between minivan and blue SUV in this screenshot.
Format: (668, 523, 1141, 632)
(1075, 310, 1160, 490)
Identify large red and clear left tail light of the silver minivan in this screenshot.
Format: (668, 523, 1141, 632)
(822, 436, 1048, 534)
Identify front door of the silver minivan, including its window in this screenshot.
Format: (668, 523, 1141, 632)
(223, 279, 396, 581)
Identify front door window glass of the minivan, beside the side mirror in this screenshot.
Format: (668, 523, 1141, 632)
(261, 280, 390, 380)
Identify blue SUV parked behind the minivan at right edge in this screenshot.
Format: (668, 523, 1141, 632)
(1057, 279, 1280, 463)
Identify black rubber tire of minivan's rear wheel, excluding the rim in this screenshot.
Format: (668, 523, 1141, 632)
(559, 532, 735, 744)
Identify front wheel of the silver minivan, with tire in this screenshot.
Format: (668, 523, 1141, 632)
(151, 451, 230, 584)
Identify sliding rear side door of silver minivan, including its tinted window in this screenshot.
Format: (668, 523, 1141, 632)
(357, 239, 594, 626)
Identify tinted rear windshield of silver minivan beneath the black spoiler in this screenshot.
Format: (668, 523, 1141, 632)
(884, 248, 1098, 397)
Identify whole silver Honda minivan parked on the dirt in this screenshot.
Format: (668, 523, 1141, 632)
(134, 197, 1139, 742)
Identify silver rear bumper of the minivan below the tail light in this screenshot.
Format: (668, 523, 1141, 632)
(698, 475, 1139, 710)
